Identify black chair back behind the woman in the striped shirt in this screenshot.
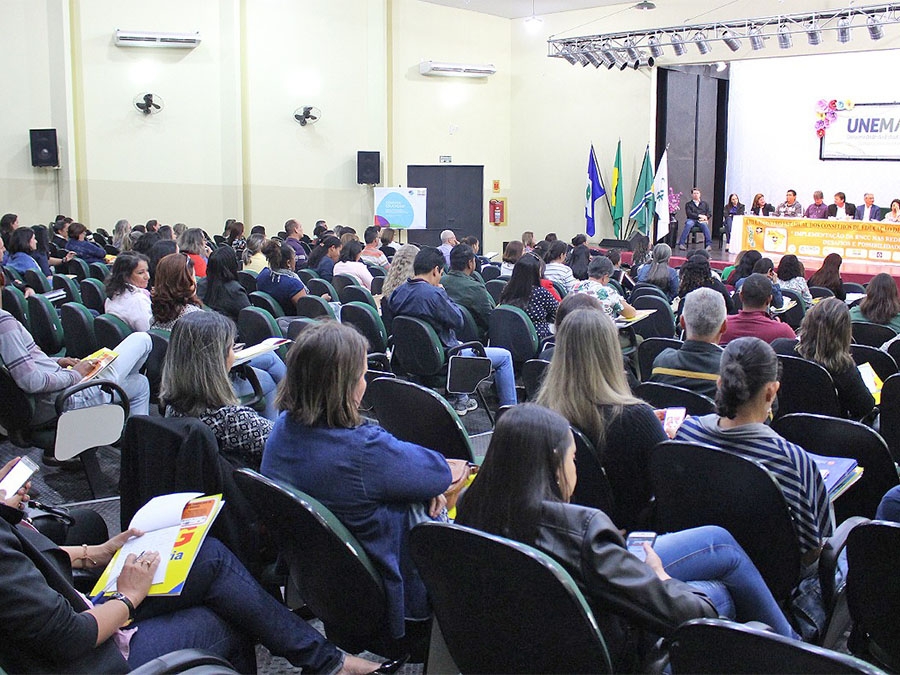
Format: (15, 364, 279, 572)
(650, 441, 801, 602)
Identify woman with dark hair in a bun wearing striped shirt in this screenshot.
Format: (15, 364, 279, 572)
(675, 338, 834, 564)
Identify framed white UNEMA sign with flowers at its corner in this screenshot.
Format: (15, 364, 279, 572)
(819, 103, 900, 161)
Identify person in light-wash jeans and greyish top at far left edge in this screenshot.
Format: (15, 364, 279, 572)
(0, 271, 152, 456)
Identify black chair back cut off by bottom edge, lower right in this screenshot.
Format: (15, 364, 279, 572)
(669, 619, 881, 675)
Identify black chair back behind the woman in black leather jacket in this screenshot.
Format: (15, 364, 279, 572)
(410, 523, 612, 673)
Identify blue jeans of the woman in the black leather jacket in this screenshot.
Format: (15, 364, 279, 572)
(653, 525, 797, 638)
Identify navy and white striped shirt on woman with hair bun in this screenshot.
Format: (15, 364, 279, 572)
(675, 414, 834, 553)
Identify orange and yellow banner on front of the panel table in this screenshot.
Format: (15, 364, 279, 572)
(731, 216, 900, 263)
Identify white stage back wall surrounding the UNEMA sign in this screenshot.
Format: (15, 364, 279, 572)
(725, 50, 900, 213)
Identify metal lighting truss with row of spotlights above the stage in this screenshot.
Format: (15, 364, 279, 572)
(547, 3, 900, 70)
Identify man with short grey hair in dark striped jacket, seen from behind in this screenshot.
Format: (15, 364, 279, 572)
(650, 288, 727, 398)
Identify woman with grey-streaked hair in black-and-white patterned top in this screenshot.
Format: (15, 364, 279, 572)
(159, 312, 272, 471)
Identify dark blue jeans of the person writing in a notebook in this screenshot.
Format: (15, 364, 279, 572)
(120, 538, 344, 673)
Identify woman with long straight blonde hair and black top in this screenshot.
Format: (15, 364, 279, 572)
(537, 309, 666, 530)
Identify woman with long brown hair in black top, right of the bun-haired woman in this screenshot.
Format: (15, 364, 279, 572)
(790, 298, 872, 420)
